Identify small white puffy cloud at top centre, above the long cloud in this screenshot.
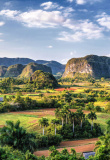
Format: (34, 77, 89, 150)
(40, 1, 59, 10)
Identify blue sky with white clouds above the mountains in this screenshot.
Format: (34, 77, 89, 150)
(0, 0, 110, 64)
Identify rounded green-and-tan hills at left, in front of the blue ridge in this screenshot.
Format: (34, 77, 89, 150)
(0, 62, 52, 78)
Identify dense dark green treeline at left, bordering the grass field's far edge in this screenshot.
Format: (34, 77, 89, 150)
(0, 94, 61, 113)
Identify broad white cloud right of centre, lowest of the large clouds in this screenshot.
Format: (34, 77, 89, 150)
(58, 19, 103, 42)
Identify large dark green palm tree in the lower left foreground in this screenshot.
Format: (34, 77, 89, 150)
(0, 121, 37, 153)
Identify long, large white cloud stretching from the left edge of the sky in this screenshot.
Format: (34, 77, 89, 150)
(0, 10, 64, 28)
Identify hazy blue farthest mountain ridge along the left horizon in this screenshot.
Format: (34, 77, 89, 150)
(0, 57, 65, 76)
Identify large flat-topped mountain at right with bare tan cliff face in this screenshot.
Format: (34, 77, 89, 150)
(63, 55, 110, 78)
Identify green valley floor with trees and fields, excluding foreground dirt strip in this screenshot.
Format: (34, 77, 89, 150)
(0, 70, 110, 160)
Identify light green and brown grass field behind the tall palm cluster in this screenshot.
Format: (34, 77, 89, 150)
(0, 109, 110, 133)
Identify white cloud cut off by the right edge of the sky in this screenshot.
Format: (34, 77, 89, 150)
(96, 12, 110, 30)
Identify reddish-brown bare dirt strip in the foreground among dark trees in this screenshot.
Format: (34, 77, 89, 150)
(34, 138, 98, 157)
